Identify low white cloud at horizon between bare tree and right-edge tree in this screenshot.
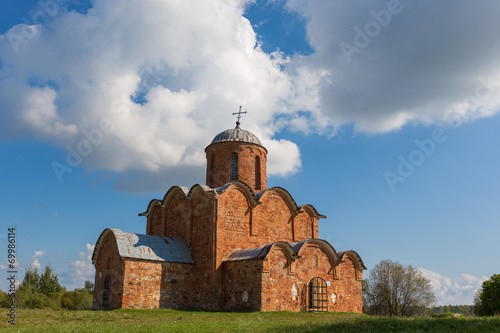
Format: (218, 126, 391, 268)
(420, 268, 488, 305)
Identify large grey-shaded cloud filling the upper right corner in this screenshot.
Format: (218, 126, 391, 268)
(286, 0, 500, 132)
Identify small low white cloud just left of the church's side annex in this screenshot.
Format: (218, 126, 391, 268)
(60, 244, 95, 290)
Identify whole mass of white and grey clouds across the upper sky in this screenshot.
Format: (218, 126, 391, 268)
(0, 0, 500, 191)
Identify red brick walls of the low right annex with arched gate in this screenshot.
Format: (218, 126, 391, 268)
(219, 244, 361, 312)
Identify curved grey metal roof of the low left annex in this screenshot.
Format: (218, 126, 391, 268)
(92, 229, 193, 265)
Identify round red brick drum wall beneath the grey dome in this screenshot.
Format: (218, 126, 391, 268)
(205, 141, 267, 192)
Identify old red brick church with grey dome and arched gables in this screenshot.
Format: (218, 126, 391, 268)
(92, 115, 366, 312)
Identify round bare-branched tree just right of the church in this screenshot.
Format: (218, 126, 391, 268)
(363, 260, 436, 316)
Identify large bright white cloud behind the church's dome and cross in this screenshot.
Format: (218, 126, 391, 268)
(0, 0, 300, 192)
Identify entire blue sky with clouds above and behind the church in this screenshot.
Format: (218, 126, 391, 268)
(0, 0, 500, 304)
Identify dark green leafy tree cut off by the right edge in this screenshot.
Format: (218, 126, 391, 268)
(474, 274, 500, 316)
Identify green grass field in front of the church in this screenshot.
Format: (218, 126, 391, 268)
(0, 309, 500, 332)
